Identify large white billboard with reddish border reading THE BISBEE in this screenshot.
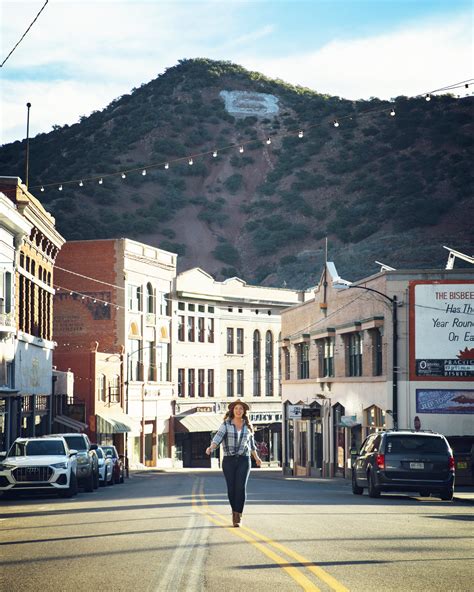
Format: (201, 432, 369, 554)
(410, 281, 474, 380)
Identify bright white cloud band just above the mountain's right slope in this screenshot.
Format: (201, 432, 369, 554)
(240, 15, 473, 99)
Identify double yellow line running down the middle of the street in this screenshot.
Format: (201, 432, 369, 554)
(192, 479, 349, 592)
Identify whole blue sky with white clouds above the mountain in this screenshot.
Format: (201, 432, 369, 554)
(0, 0, 473, 144)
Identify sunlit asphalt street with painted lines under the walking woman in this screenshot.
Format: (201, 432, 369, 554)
(0, 469, 474, 592)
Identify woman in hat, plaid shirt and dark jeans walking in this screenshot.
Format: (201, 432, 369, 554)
(206, 399, 262, 527)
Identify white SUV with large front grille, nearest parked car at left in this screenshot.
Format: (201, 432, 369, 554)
(0, 436, 77, 497)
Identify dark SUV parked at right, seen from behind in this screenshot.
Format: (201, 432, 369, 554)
(352, 430, 454, 500)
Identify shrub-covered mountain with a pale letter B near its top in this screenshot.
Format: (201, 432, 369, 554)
(0, 59, 474, 288)
